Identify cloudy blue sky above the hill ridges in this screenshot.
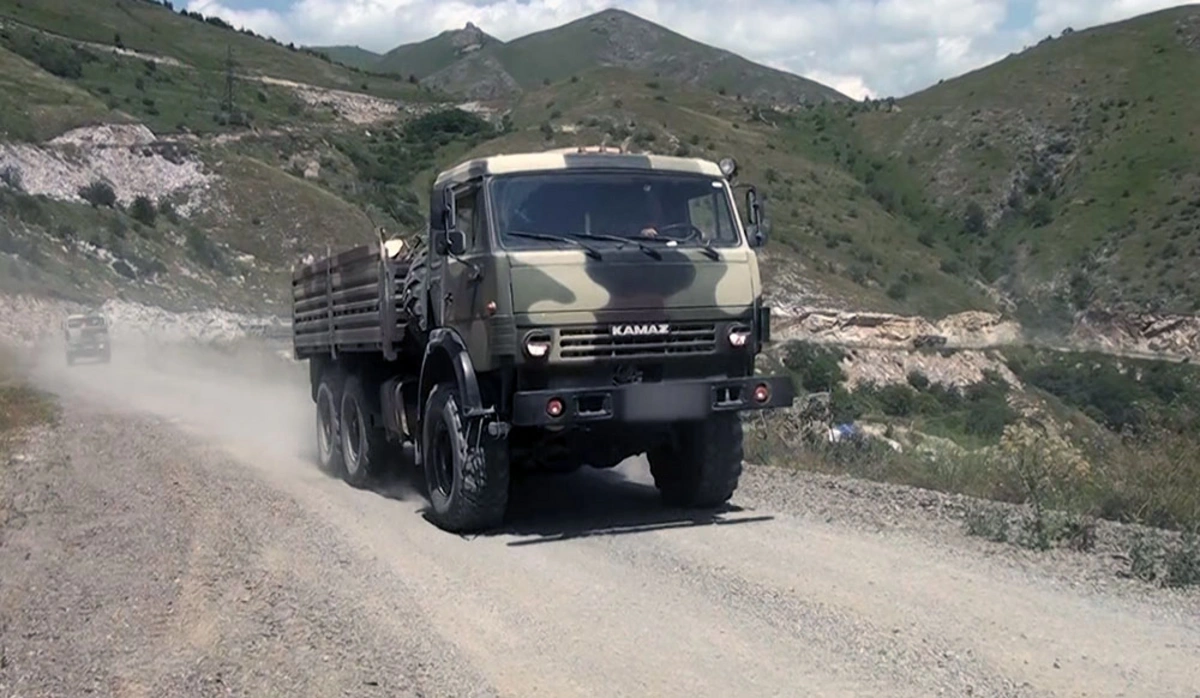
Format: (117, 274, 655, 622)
(187, 0, 1181, 98)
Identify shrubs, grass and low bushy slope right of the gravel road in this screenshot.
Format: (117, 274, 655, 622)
(748, 343, 1200, 586)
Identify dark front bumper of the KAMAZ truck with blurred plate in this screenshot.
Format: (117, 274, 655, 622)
(512, 375, 796, 427)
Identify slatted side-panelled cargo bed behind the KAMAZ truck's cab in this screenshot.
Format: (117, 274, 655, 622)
(292, 243, 409, 359)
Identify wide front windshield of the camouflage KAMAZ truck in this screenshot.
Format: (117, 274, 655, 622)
(491, 173, 738, 248)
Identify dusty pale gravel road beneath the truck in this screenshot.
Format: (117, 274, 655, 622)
(0, 347, 1200, 698)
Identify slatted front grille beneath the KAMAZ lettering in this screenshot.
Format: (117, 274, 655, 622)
(557, 323, 716, 360)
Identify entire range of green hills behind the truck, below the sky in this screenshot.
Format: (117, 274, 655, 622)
(0, 0, 1200, 336)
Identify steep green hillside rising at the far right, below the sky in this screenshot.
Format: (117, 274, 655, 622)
(849, 5, 1200, 326)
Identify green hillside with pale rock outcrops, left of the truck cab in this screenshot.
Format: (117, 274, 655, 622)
(0, 0, 472, 311)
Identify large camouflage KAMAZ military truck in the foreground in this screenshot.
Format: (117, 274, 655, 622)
(292, 148, 794, 531)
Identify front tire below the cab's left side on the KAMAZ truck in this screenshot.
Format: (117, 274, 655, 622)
(421, 383, 510, 534)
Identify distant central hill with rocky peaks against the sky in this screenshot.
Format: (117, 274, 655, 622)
(333, 10, 847, 103)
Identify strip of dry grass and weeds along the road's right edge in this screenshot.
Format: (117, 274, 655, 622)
(746, 407, 1200, 586)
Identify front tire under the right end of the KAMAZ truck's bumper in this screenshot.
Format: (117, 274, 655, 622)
(647, 414, 743, 509)
